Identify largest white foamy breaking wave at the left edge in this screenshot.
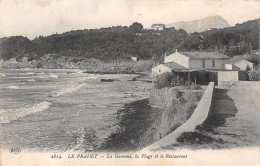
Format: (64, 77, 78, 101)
(0, 101, 52, 124)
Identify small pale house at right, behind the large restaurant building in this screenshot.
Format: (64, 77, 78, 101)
(225, 59, 254, 70)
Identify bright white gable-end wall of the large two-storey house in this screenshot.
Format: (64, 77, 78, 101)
(164, 52, 189, 68)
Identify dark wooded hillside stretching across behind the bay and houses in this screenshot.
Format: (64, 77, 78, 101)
(0, 19, 260, 61)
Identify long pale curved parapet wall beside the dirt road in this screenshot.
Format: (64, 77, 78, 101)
(141, 82, 215, 151)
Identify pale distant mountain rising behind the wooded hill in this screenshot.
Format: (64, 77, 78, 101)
(166, 15, 230, 33)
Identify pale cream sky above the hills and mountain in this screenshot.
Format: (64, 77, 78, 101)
(0, 0, 260, 39)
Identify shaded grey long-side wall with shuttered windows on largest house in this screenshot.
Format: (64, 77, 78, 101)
(189, 59, 224, 69)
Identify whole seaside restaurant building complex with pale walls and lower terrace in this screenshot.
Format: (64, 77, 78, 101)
(152, 50, 248, 84)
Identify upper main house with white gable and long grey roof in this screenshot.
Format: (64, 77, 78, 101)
(164, 50, 229, 69)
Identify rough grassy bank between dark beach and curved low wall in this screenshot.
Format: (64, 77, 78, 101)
(149, 87, 204, 140)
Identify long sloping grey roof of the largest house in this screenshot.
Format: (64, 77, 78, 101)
(180, 52, 229, 59)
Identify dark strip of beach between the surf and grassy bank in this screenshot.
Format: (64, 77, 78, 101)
(95, 98, 164, 152)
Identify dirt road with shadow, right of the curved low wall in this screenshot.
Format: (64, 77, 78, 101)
(162, 82, 260, 149)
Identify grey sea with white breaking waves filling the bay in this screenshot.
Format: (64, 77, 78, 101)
(0, 69, 151, 151)
